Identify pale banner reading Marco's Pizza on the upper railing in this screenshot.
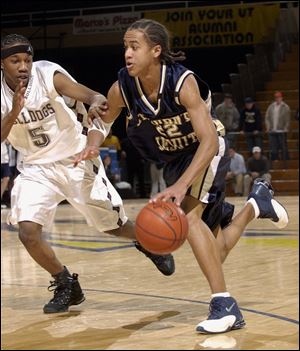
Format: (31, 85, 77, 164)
(73, 12, 141, 34)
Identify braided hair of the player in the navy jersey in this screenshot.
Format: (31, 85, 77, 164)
(127, 18, 186, 63)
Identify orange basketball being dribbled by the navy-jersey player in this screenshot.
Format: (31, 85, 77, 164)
(135, 201, 188, 255)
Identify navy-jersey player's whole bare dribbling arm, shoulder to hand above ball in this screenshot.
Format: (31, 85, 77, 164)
(152, 75, 218, 206)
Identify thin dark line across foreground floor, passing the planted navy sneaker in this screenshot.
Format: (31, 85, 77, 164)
(1, 282, 299, 325)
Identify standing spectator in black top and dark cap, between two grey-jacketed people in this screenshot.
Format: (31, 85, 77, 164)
(240, 97, 262, 154)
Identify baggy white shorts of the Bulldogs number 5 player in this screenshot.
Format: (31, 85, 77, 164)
(8, 157, 127, 231)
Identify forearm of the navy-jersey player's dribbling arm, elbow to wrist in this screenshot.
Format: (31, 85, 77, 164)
(178, 133, 219, 188)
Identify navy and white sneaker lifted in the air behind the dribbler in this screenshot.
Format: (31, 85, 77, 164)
(247, 178, 289, 229)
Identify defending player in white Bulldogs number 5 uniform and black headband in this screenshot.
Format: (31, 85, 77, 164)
(1, 34, 174, 313)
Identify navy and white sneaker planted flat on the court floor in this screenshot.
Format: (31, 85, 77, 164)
(196, 296, 246, 334)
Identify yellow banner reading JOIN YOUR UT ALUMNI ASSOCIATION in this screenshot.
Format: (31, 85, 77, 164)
(144, 3, 280, 48)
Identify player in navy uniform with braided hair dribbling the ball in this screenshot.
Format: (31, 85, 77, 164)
(77, 19, 288, 333)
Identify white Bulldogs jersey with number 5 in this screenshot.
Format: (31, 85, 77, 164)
(1, 61, 87, 164)
